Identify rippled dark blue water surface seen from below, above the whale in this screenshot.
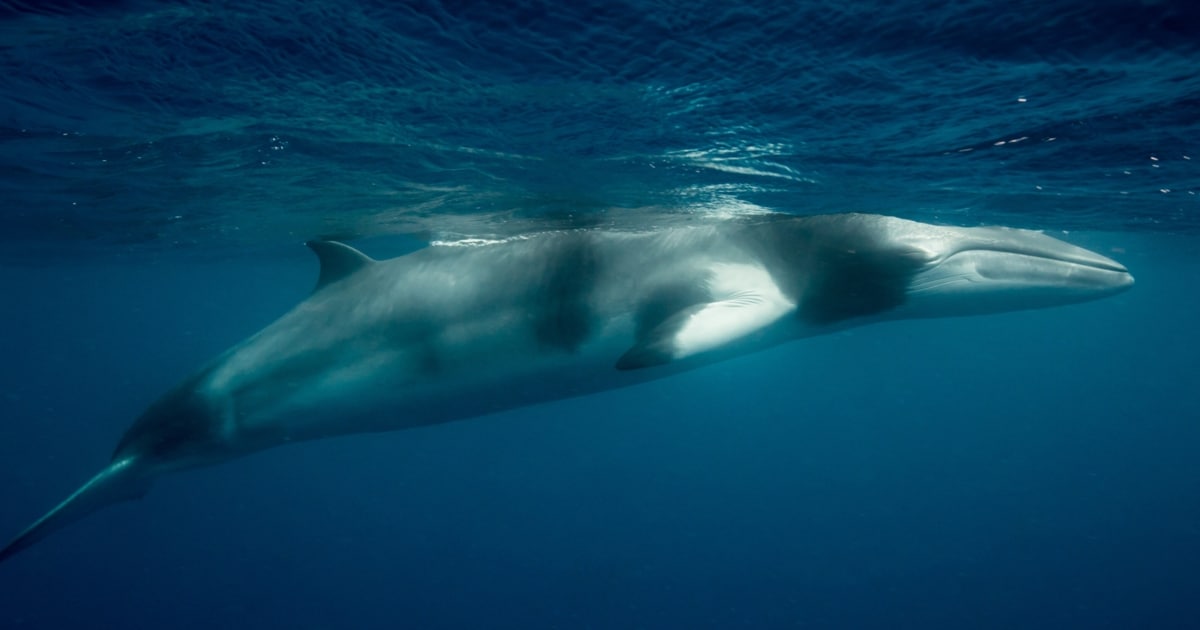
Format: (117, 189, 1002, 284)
(0, 0, 1200, 259)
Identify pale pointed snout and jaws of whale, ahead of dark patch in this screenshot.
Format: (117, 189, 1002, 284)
(896, 222, 1134, 317)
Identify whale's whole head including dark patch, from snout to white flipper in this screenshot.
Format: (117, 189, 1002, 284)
(752, 212, 1133, 329)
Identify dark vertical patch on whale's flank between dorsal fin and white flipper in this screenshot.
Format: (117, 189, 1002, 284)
(533, 234, 600, 352)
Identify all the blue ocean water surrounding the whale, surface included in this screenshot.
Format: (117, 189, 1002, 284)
(0, 0, 1200, 629)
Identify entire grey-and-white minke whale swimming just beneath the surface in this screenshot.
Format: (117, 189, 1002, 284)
(0, 214, 1134, 562)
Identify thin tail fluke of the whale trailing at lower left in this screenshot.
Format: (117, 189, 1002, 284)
(0, 457, 150, 563)
